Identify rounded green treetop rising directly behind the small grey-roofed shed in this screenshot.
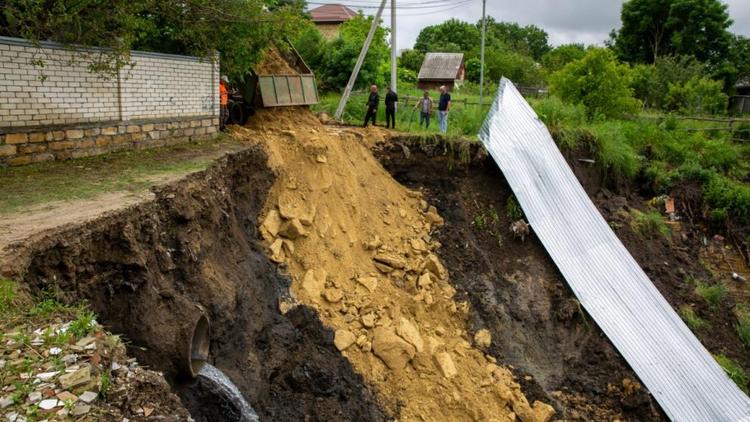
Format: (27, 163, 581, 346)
(414, 19, 480, 52)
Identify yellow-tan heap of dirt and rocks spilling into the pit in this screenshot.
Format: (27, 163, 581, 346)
(235, 108, 554, 421)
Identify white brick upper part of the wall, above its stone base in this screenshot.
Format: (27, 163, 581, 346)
(0, 37, 219, 128)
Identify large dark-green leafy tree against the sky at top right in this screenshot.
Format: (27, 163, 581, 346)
(613, 0, 732, 64)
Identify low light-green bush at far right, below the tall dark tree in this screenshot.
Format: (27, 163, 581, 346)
(666, 76, 728, 114)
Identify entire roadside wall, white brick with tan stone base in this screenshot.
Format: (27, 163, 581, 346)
(0, 37, 219, 166)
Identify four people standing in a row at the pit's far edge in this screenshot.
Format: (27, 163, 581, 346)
(363, 85, 451, 133)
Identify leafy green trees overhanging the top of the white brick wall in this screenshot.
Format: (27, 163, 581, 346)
(0, 0, 302, 77)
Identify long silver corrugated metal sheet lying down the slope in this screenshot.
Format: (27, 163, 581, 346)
(480, 79, 750, 421)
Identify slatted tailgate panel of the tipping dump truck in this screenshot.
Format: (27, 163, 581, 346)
(258, 75, 319, 107)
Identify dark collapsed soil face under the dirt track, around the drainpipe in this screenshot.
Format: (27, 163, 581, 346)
(10, 148, 388, 420)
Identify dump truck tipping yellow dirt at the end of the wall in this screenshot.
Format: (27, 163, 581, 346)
(227, 43, 320, 125)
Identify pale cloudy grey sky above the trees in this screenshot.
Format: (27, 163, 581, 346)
(340, 0, 750, 50)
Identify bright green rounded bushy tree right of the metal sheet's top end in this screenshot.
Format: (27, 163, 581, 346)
(550, 48, 640, 119)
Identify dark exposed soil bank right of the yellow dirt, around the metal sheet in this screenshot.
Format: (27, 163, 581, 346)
(376, 139, 744, 420)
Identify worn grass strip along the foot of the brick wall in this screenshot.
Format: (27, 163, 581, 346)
(0, 138, 236, 214)
